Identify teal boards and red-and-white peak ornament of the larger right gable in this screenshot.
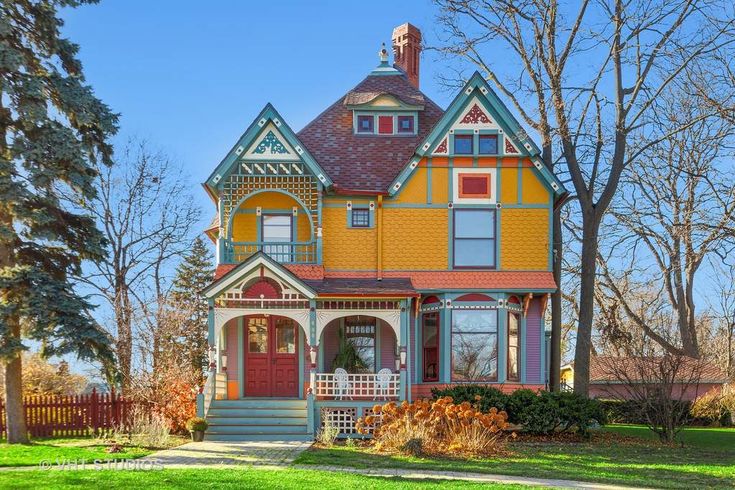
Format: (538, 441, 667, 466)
(388, 72, 567, 196)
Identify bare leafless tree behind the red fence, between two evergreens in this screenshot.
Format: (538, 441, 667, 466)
(83, 141, 200, 388)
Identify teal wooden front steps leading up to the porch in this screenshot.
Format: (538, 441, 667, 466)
(204, 398, 314, 441)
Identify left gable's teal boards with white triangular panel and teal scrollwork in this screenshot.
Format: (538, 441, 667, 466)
(204, 103, 333, 196)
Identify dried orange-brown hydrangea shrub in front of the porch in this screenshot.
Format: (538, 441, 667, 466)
(356, 395, 508, 456)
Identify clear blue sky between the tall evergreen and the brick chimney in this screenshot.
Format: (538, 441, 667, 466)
(62, 0, 454, 218)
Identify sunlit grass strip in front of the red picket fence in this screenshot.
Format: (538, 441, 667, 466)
(0, 437, 184, 467)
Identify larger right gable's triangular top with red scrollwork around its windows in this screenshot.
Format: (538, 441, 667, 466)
(389, 72, 566, 196)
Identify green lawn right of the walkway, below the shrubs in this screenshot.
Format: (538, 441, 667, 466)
(295, 426, 735, 489)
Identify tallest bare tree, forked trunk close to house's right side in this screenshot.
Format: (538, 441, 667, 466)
(436, 0, 735, 394)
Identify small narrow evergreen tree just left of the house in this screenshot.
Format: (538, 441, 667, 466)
(171, 237, 214, 375)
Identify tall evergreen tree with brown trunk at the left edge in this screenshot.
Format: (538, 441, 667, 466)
(0, 0, 117, 443)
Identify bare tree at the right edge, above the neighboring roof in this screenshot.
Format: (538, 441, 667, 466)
(600, 91, 735, 358)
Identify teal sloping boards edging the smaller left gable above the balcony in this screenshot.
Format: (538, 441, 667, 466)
(205, 102, 333, 195)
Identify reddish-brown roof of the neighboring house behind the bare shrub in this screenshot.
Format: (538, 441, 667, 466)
(590, 356, 728, 384)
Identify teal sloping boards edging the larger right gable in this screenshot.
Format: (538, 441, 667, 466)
(389, 72, 567, 195)
